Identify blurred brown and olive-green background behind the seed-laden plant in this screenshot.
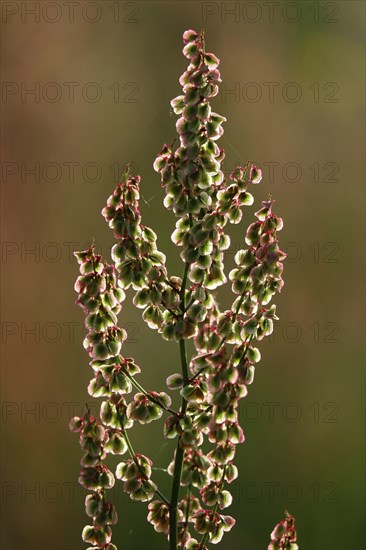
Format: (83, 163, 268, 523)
(0, 0, 365, 550)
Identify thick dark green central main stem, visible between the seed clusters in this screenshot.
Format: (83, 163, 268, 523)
(169, 263, 189, 550)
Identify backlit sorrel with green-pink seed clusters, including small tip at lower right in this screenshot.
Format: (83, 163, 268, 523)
(70, 30, 297, 550)
